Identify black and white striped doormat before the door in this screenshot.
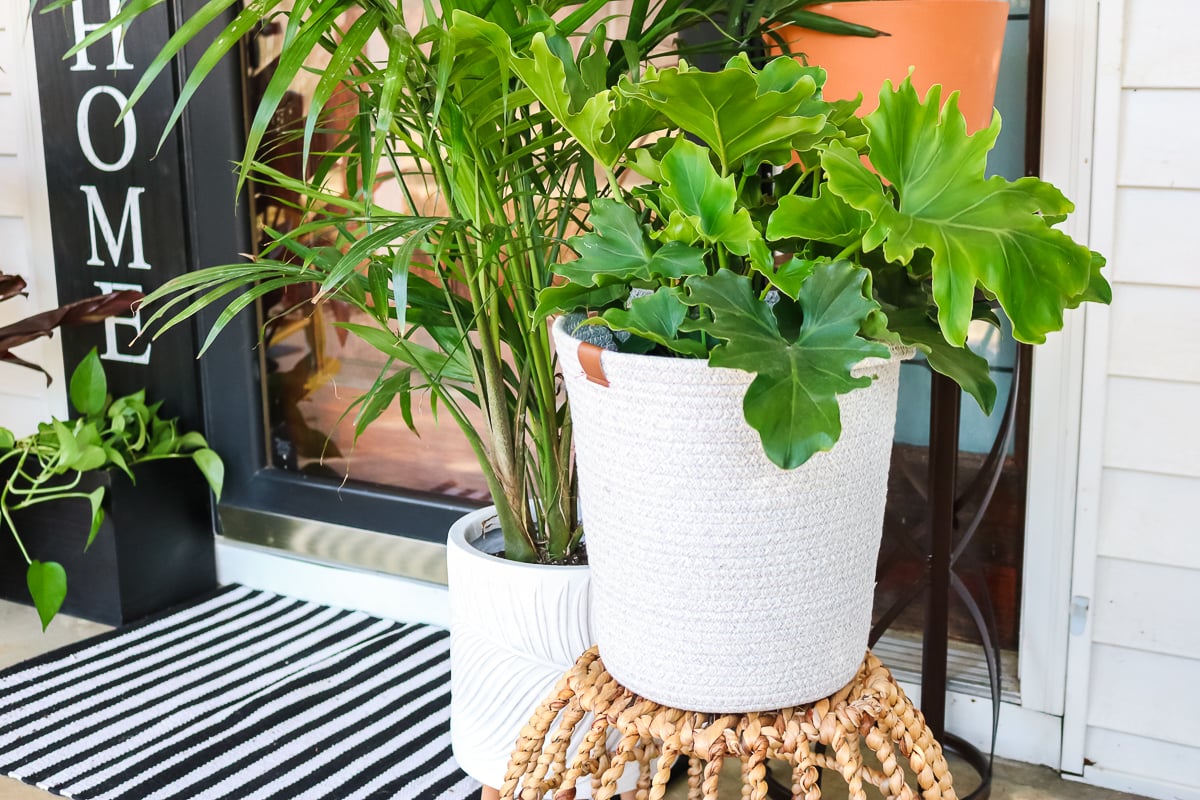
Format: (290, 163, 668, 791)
(0, 585, 480, 800)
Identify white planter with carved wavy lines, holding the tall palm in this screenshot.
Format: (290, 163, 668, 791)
(446, 509, 637, 798)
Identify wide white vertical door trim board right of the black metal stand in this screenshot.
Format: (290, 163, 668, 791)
(1018, 0, 1096, 724)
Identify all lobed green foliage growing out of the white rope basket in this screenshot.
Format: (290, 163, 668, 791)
(490, 48, 1111, 468)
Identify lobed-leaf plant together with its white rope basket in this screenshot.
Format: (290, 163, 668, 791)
(508, 50, 1110, 711)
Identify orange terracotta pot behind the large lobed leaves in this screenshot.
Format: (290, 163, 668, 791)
(769, 0, 1008, 131)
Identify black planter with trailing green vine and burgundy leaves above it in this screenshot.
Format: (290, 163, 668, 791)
(0, 276, 223, 630)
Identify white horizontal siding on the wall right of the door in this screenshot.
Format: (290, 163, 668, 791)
(1070, 0, 1200, 798)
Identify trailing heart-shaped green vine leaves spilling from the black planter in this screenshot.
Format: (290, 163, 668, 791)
(0, 349, 224, 630)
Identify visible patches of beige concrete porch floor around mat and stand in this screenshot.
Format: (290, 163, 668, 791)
(0, 601, 1142, 800)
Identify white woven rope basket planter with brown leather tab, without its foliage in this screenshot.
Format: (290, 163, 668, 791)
(554, 320, 908, 712)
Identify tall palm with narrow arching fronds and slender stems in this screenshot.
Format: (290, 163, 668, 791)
(62, 0, 840, 563)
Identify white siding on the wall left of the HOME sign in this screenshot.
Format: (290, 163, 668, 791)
(0, 0, 66, 433)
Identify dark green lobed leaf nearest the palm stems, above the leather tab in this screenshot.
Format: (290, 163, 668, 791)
(554, 198, 706, 287)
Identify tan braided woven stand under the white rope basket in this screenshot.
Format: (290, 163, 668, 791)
(500, 648, 956, 800)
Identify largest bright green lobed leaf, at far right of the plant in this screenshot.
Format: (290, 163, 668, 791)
(821, 79, 1092, 345)
